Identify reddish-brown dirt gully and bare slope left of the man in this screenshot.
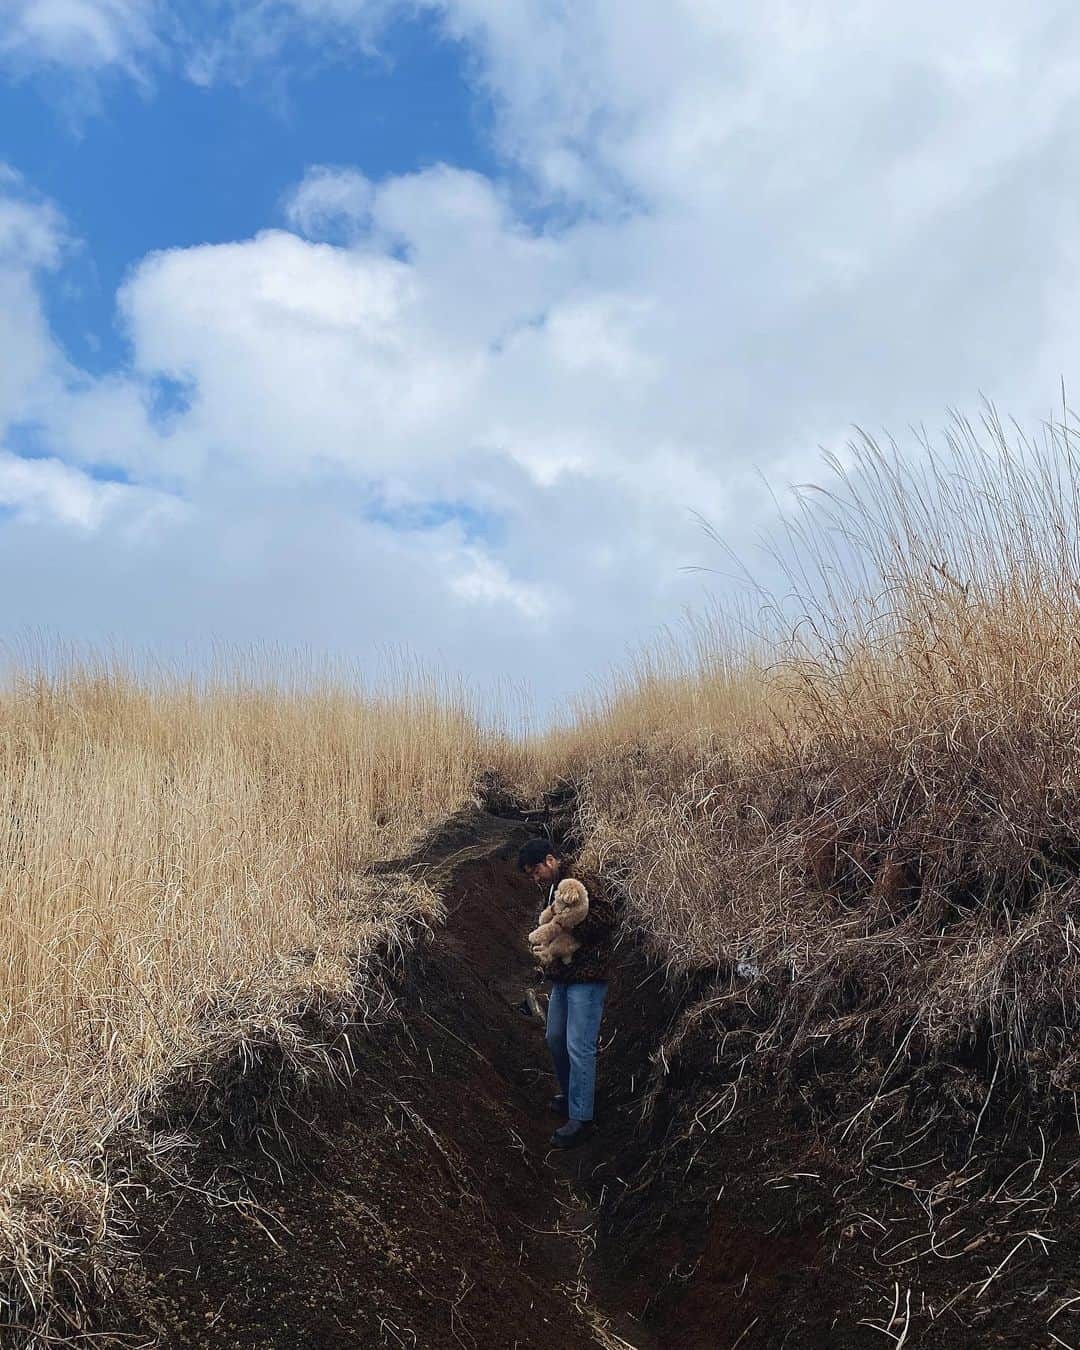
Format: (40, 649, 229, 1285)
(124, 817, 655, 1350)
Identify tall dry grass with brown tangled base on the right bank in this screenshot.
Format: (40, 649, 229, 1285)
(562, 414, 1080, 1110)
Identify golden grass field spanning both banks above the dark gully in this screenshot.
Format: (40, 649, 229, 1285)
(0, 407, 1080, 1328)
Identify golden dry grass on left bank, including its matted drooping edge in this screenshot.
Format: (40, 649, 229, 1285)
(0, 660, 494, 1343)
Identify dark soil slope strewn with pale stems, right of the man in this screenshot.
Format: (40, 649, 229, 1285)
(590, 907, 1080, 1350)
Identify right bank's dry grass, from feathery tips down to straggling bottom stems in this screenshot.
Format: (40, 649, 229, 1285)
(563, 417, 1080, 1345)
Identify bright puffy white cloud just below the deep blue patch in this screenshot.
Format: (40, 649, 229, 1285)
(114, 231, 480, 477)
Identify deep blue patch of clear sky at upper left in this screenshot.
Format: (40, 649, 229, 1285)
(0, 18, 494, 373)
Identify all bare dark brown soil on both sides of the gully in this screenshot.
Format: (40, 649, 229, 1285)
(80, 813, 1080, 1350)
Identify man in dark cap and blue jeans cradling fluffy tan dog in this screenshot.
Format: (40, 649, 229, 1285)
(517, 840, 616, 1149)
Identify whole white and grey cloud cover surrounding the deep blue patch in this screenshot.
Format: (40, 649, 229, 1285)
(0, 0, 1080, 693)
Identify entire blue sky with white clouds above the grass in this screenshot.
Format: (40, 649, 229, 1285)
(0, 0, 1080, 716)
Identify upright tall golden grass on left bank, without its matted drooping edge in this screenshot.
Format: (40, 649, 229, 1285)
(0, 662, 491, 1185)
